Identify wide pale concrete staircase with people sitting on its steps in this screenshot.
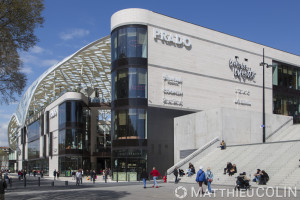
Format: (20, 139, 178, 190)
(171, 141, 300, 188)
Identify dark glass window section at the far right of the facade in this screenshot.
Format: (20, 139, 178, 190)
(273, 61, 300, 123)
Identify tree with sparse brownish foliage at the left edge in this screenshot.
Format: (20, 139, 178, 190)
(0, 0, 44, 104)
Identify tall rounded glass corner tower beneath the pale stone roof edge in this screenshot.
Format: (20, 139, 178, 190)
(111, 25, 148, 181)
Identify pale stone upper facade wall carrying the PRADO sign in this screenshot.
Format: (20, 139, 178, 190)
(111, 9, 300, 117)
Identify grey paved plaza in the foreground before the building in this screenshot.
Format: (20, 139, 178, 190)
(2, 178, 300, 200)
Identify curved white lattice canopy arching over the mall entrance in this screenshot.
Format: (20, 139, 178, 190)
(8, 36, 111, 149)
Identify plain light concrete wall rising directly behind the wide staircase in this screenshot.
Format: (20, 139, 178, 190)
(174, 108, 292, 163)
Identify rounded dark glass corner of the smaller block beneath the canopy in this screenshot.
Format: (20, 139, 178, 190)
(58, 101, 90, 176)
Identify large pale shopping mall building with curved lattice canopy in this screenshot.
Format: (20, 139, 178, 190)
(8, 9, 300, 180)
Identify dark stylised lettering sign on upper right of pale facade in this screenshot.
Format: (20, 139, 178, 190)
(229, 58, 256, 81)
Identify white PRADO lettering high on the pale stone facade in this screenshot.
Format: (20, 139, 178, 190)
(153, 28, 192, 47)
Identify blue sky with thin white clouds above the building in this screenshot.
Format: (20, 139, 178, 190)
(0, 0, 300, 146)
